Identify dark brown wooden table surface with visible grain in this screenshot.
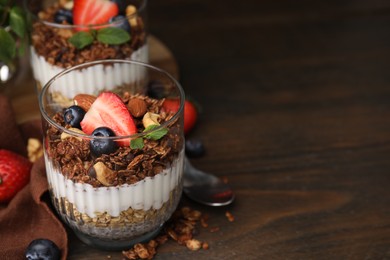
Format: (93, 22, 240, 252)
(6, 0, 390, 259)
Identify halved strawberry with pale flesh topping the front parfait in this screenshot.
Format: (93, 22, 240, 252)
(80, 92, 137, 146)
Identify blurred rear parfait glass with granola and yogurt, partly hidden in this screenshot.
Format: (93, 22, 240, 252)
(24, 0, 149, 93)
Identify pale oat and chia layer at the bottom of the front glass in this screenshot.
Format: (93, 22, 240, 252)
(50, 179, 181, 240)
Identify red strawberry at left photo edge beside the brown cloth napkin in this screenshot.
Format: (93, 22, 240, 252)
(0, 149, 32, 203)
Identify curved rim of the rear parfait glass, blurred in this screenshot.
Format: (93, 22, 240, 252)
(24, 0, 148, 31)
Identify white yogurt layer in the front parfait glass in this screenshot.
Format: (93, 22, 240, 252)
(45, 148, 184, 218)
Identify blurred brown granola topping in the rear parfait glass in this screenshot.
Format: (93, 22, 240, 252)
(31, 4, 146, 68)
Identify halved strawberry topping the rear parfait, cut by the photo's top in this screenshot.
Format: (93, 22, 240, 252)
(73, 0, 119, 28)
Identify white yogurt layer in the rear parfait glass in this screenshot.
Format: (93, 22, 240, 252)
(31, 44, 149, 98)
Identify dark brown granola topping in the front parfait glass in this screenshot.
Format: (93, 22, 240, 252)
(46, 93, 183, 187)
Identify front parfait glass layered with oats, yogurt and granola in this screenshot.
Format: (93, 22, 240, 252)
(39, 60, 184, 250)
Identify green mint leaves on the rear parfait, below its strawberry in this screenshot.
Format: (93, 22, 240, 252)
(69, 27, 131, 49)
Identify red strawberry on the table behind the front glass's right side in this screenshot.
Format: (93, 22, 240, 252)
(163, 99, 198, 134)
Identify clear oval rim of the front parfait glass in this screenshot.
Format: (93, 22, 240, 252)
(38, 59, 185, 141)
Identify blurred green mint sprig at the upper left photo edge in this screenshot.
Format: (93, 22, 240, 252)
(0, 3, 27, 65)
